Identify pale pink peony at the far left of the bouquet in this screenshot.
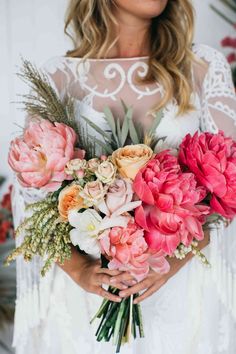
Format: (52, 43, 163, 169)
(8, 120, 78, 191)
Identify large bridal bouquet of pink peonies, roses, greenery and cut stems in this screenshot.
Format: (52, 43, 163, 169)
(6, 62, 236, 352)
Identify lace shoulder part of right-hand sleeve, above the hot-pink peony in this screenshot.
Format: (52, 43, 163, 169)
(201, 47, 236, 139)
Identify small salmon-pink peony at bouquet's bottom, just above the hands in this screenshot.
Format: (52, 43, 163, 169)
(99, 221, 170, 281)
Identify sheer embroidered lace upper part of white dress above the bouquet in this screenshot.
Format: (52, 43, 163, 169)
(43, 45, 236, 140)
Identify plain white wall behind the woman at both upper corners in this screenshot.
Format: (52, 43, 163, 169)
(0, 0, 236, 187)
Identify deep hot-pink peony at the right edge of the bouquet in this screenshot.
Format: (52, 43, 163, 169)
(179, 131, 236, 218)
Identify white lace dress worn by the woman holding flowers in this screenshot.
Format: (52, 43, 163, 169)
(10, 45, 236, 354)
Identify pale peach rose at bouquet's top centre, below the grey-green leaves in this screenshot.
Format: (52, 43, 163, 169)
(112, 144, 153, 180)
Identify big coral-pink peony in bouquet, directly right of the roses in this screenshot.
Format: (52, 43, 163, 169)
(133, 150, 209, 255)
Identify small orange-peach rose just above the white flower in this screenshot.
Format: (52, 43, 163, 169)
(58, 183, 86, 221)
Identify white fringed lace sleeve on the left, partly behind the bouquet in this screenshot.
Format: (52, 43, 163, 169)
(12, 58, 64, 353)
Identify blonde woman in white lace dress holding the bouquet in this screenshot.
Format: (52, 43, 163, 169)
(13, 0, 236, 354)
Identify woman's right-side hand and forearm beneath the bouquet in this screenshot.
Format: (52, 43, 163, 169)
(111, 231, 210, 304)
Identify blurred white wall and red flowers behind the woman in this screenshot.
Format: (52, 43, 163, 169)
(0, 0, 236, 354)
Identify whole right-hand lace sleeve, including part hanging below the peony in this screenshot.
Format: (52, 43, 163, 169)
(197, 46, 236, 323)
